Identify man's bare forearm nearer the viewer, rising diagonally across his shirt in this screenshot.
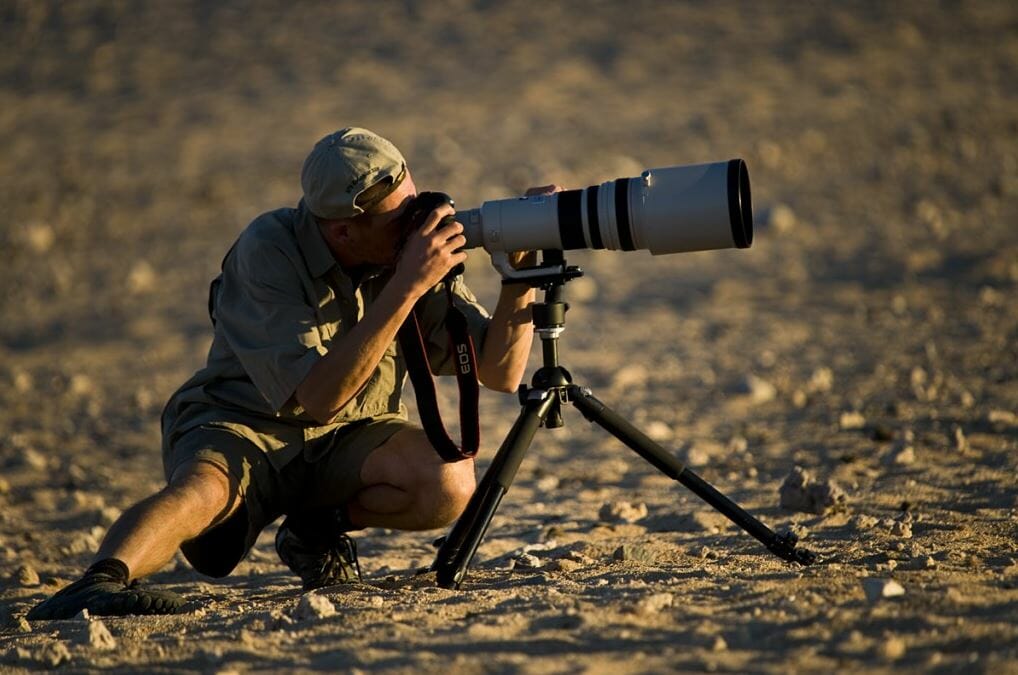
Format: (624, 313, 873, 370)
(296, 283, 416, 424)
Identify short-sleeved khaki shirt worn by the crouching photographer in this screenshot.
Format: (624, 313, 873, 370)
(162, 202, 489, 467)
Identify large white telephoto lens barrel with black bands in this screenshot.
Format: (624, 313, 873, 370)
(456, 159, 753, 255)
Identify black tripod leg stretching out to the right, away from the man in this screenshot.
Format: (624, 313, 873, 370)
(569, 385, 816, 565)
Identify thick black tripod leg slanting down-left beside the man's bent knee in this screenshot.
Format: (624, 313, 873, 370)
(432, 390, 559, 588)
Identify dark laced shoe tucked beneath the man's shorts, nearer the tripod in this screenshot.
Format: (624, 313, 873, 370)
(276, 520, 360, 590)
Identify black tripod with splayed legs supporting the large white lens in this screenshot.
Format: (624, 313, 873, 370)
(432, 256, 816, 588)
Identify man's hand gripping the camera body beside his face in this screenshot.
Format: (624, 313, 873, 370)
(390, 205, 466, 297)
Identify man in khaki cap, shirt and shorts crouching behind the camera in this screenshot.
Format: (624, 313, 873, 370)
(29, 127, 558, 619)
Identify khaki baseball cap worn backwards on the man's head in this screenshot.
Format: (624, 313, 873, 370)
(300, 126, 406, 220)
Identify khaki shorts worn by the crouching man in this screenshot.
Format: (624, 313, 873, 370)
(163, 416, 414, 577)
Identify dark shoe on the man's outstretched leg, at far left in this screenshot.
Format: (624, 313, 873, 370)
(25, 569, 184, 621)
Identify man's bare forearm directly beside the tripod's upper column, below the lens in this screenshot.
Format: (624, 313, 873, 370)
(477, 285, 535, 392)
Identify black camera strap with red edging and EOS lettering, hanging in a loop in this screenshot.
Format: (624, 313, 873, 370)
(398, 281, 480, 462)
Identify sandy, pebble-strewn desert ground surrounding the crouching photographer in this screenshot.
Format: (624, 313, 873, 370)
(0, 0, 1018, 673)
